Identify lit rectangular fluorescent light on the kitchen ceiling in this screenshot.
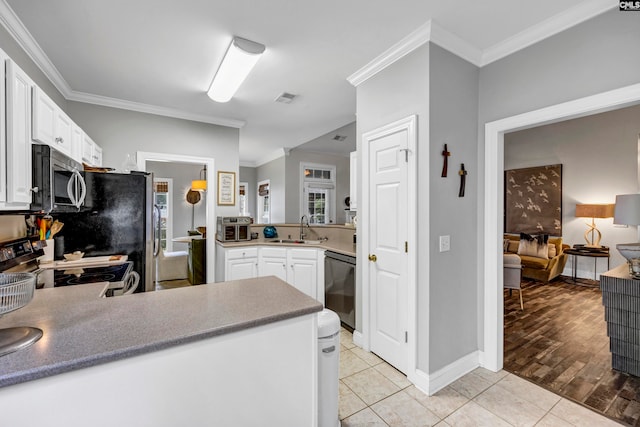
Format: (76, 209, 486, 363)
(207, 37, 265, 102)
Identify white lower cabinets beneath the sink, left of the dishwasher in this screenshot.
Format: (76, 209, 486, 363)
(216, 246, 324, 304)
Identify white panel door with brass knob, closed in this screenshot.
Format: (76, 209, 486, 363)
(368, 125, 409, 372)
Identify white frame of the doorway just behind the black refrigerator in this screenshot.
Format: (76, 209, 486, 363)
(136, 151, 217, 283)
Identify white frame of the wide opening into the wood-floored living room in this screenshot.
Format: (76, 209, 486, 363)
(479, 84, 640, 372)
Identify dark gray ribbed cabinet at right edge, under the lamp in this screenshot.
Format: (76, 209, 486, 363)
(600, 264, 640, 376)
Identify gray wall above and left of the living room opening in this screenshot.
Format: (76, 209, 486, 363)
(477, 10, 640, 349)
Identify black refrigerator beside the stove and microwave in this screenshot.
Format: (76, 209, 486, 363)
(53, 172, 154, 292)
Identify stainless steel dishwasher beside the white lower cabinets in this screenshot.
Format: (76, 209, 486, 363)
(324, 251, 356, 330)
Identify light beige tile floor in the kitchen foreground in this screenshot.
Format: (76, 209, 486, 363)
(338, 329, 619, 427)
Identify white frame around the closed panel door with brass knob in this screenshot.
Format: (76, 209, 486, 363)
(357, 114, 420, 383)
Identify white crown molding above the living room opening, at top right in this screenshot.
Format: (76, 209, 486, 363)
(479, 0, 619, 67)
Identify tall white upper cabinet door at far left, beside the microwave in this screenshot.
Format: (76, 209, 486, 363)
(6, 60, 34, 208)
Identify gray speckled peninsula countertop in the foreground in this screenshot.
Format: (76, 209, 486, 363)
(0, 276, 322, 387)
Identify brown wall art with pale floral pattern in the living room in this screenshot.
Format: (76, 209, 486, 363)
(504, 164, 562, 236)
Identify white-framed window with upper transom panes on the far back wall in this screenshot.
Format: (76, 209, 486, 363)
(300, 163, 336, 224)
